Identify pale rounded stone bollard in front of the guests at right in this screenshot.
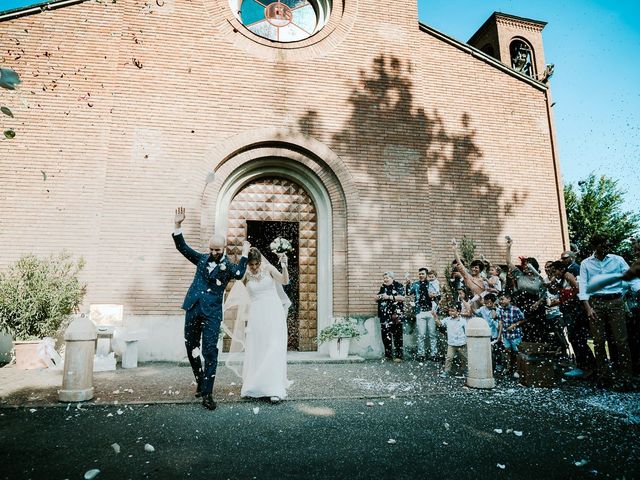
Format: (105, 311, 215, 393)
(467, 317, 496, 388)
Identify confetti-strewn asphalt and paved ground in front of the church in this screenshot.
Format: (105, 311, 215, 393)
(0, 361, 640, 480)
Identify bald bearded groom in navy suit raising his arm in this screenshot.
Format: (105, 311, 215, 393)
(173, 207, 251, 410)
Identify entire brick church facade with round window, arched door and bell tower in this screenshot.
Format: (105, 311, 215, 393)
(0, 0, 568, 359)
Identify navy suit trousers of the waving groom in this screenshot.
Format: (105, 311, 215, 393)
(184, 301, 222, 395)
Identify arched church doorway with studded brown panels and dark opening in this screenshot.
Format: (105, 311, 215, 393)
(227, 175, 318, 351)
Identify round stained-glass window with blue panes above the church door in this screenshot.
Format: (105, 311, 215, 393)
(229, 0, 331, 42)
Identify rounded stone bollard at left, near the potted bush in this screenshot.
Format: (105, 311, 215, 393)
(58, 315, 97, 402)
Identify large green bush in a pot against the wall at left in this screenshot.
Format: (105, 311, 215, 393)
(0, 252, 85, 368)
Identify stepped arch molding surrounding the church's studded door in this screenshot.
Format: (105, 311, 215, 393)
(200, 128, 358, 344)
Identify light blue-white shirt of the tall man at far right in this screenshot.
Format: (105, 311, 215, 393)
(578, 253, 640, 300)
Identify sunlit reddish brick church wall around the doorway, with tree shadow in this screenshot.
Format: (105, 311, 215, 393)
(0, 0, 563, 322)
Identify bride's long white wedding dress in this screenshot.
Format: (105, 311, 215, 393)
(241, 271, 290, 399)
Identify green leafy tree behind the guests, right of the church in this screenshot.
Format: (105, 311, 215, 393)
(564, 174, 640, 261)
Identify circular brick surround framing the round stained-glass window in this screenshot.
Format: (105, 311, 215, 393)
(209, 0, 358, 61)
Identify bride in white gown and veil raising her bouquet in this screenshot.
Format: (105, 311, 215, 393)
(225, 248, 291, 403)
